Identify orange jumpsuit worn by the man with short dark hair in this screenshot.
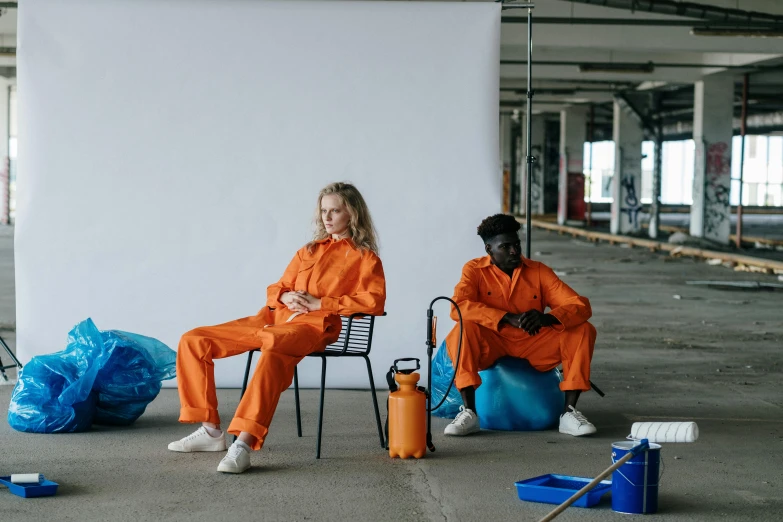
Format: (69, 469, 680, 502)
(446, 256, 596, 391)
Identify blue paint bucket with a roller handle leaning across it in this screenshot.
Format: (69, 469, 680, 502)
(612, 440, 661, 515)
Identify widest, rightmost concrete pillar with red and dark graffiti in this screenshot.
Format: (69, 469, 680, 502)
(690, 75, 734, 245)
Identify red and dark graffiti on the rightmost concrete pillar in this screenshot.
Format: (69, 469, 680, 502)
(704, 142, 731, 235)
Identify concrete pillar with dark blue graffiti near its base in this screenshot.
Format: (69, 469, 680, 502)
(609, 101, 644, 234)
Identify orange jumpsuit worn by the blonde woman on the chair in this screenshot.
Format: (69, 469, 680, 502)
(177, 238, 386, 449)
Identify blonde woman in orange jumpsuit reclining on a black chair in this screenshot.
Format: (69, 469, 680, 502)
(169, 183, 386, 473)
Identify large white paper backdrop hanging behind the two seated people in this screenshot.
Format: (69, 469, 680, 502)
(16, 0, 500, 387)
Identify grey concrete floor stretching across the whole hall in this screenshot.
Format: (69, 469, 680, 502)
(0, 225, 783, 522)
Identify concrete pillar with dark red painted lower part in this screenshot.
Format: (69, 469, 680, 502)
(557, 106, 587, 225)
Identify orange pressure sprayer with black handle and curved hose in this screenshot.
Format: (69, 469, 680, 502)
(386, 297, 462, 459)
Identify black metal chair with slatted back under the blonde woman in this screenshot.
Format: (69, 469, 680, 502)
(239, 312, 386, 459)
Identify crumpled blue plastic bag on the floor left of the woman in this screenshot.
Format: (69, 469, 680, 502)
(8, 319, 177, 433)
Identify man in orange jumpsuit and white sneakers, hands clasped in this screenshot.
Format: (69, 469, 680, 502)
(445, 214, 596, 436)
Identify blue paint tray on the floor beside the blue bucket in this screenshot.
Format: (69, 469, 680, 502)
(514, 474, 612, 507)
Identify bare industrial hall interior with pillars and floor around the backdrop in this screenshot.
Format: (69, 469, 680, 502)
(0, 0, 783, 522)
